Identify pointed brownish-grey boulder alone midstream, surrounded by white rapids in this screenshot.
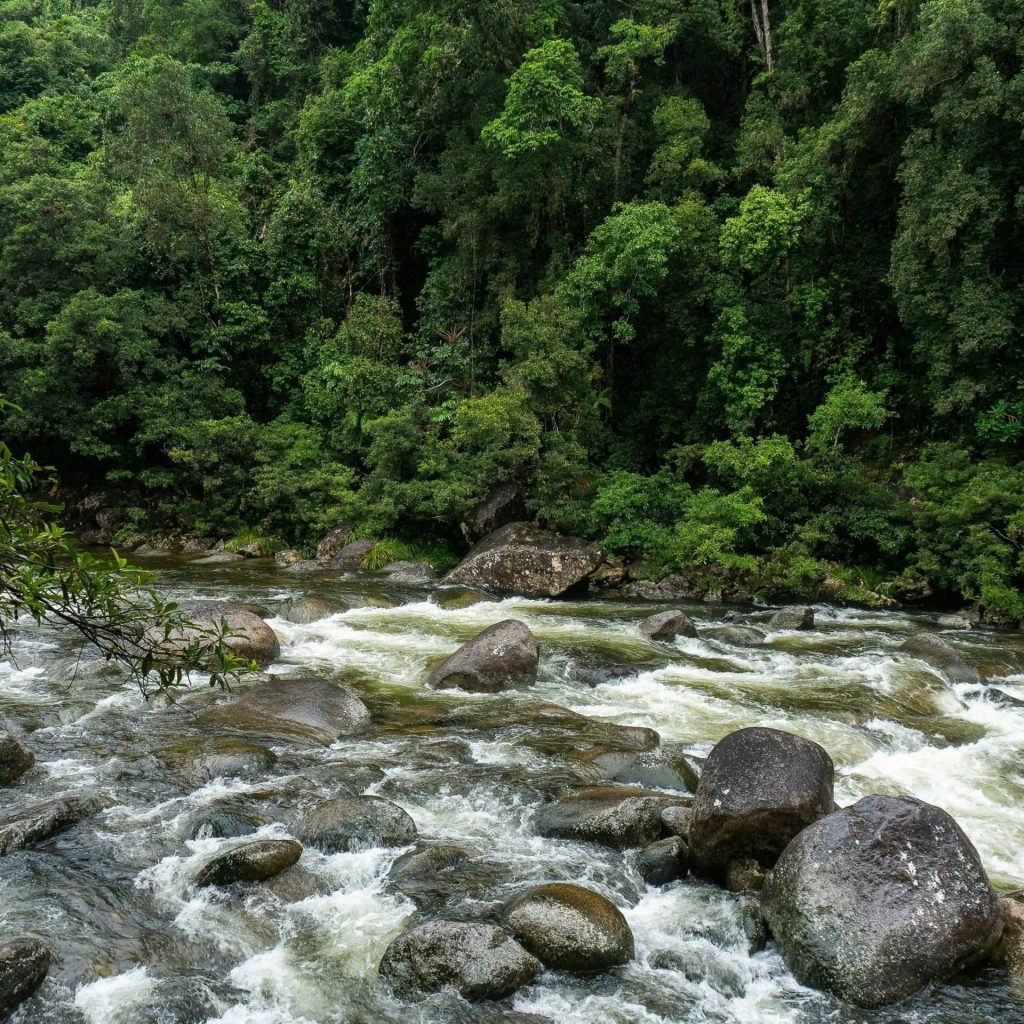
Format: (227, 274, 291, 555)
(427, 618, 540, 693)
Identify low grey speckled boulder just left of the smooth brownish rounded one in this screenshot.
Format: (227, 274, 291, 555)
(380, 921, 541, 1000)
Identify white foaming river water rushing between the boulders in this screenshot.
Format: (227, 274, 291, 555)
(0, 559, 1024, 1024)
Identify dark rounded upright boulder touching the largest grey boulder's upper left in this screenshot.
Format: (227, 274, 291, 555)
(689, 728, 835, 880)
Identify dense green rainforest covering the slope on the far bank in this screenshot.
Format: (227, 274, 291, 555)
(0, 0, 1024, 620)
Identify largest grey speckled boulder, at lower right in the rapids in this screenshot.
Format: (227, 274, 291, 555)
(763, 797, 1002, 1008)
